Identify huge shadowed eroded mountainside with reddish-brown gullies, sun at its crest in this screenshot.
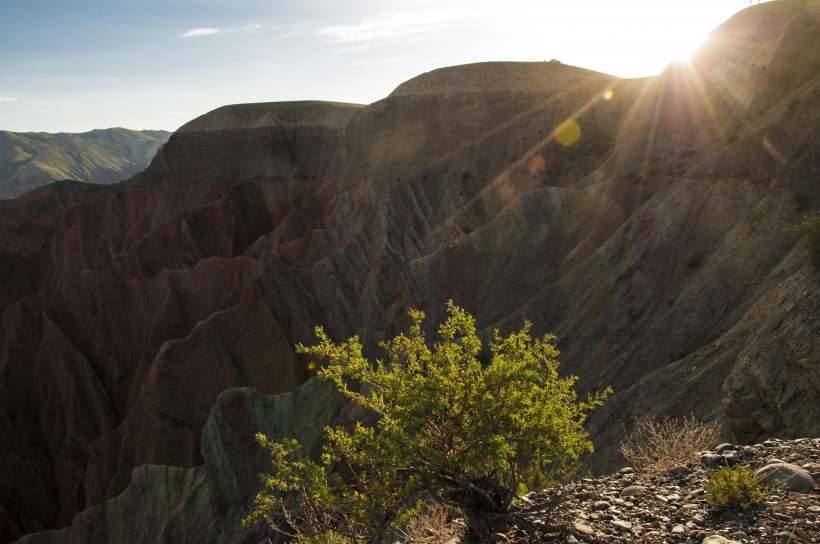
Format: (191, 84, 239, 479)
(0, 0, 820, 542)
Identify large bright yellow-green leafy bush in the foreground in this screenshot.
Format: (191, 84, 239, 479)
(245, 302, 609, 542)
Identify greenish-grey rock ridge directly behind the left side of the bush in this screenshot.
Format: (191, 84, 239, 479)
(15, 379, 344, 544)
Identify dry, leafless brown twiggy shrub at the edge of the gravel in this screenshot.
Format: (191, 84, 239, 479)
(618, 415, 718, 473)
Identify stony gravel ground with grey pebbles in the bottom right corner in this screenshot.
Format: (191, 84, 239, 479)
(484, 439, 820, 544)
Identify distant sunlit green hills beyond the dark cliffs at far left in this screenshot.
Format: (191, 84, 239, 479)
(0, 128, 171, 198)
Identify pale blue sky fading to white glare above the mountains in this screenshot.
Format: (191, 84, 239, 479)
(0, 0, 768, 132)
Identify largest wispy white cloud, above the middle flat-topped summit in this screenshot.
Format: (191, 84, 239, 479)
(318, 10, 470, 42)
